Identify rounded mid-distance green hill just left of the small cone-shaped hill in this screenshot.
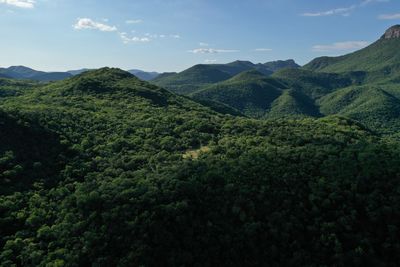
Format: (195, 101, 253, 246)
(191, 70, 287, 117)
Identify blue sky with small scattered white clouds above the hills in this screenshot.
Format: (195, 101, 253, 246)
(0, 0, 400, 72)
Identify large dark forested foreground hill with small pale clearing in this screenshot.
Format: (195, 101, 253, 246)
(0, 68, 400, 266)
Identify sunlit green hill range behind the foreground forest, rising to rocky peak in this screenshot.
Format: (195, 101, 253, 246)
(154, 26, 400, 135)
